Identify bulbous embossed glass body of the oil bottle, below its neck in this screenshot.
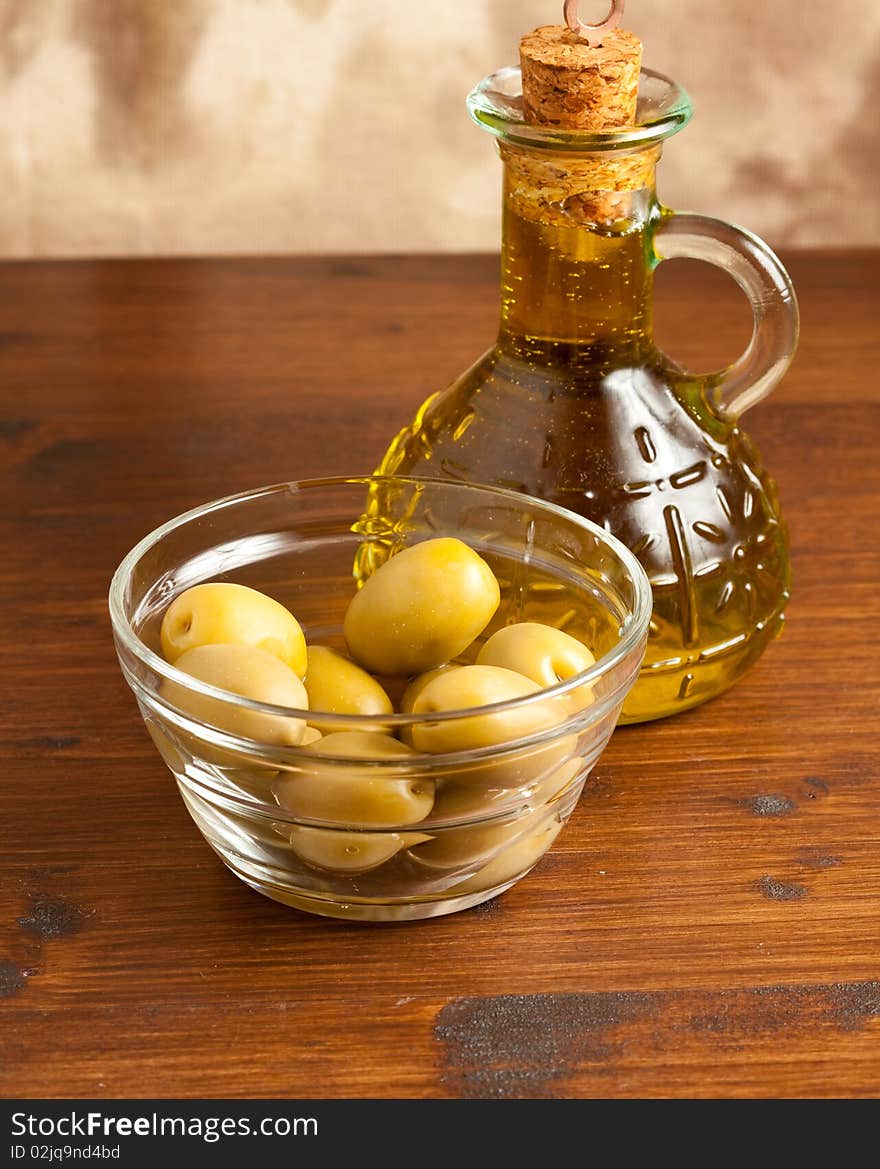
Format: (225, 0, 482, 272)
(373, 334, 789, 721)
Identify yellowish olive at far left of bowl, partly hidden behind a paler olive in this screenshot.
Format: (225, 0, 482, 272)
(159, 581, 306, 678)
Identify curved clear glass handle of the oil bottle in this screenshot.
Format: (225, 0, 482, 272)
(654, 210, 799, 419)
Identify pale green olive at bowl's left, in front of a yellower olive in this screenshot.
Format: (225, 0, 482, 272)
(162, 645, 309, 766)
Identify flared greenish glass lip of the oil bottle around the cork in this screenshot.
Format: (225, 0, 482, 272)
(467, 65, 693, 153)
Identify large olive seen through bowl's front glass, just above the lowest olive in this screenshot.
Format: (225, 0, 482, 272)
(272, 731, 434, 828)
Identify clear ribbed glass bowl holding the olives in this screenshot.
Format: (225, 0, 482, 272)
(110, 476, 651, 921)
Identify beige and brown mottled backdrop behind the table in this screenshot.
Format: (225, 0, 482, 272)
(0, 0, 880, 257)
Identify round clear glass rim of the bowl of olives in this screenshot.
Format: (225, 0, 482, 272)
(109, 475, 653, 748)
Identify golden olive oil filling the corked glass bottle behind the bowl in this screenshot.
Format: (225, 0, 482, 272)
(372, 158, 790, 722)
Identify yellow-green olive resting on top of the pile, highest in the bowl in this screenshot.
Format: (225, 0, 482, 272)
(345, 537, 500, 675)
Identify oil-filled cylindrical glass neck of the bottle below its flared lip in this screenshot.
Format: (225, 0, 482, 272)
(500, 145, 659, 361)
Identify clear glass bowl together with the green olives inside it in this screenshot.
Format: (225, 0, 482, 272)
(110, 476, 651, 921)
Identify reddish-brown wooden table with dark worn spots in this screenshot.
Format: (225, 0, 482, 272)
(0, 253, 880, 1098)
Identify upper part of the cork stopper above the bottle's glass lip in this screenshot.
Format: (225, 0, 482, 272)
(520, 25, 642, 132)
